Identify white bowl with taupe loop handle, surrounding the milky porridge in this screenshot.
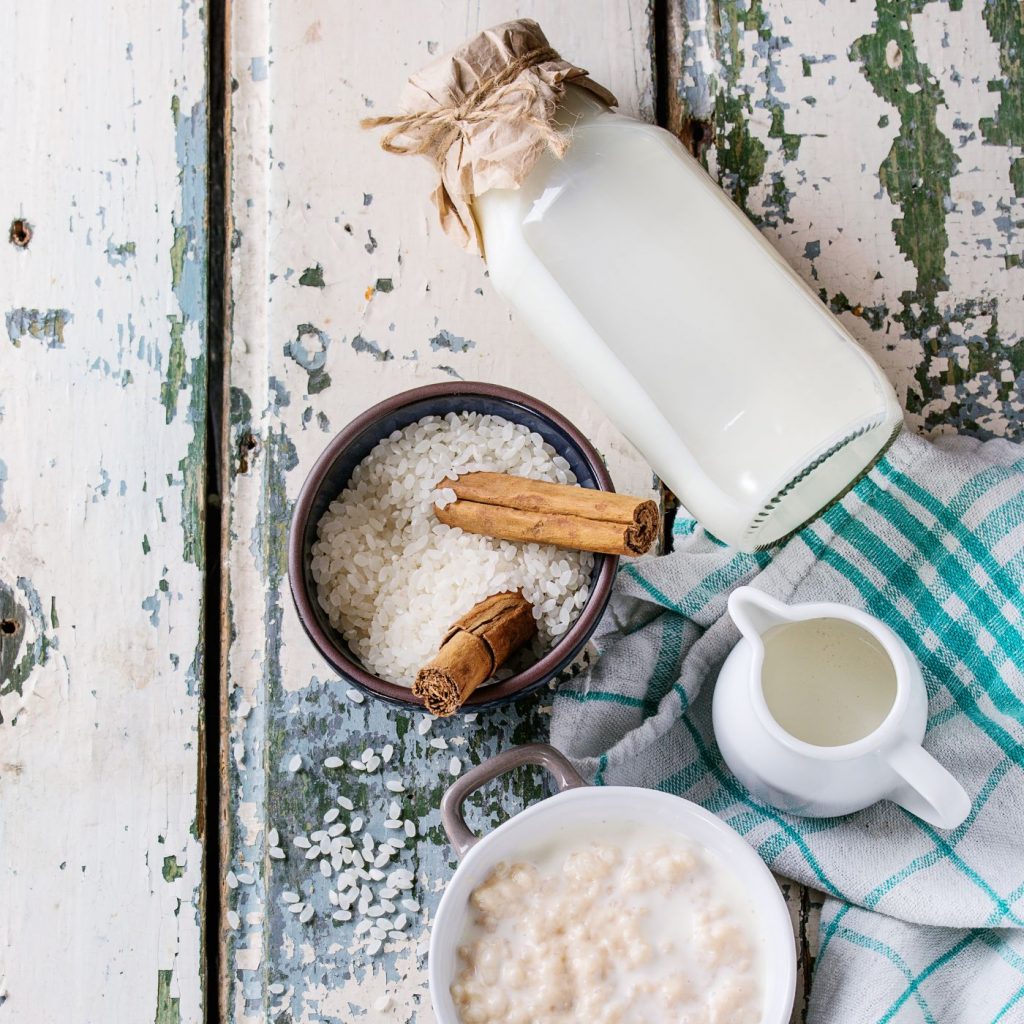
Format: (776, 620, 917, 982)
(429, 743, 797, 1024)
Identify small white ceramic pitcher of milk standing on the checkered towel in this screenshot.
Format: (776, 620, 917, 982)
(713, 587, 971, 828)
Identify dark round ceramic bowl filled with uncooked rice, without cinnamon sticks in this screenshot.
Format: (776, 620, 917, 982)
(288, 381, 617, 711)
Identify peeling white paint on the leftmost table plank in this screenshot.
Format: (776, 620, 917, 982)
(0, 0, 206, 1024)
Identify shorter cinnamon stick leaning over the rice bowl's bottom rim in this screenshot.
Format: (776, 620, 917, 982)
(413, 591, 537, 717)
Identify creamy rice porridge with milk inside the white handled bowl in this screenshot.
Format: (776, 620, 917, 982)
(451, 824, 763, 1024)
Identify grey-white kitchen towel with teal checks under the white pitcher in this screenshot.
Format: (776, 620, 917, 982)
(551, 434, 1024, 1024)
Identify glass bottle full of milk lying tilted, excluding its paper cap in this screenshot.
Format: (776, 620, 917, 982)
(472, 85, 902, 551)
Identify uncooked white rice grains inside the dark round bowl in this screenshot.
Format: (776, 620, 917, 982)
(311, 413, 594, 686)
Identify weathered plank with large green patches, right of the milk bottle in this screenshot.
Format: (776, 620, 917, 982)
(667, 0, 1024, 1022)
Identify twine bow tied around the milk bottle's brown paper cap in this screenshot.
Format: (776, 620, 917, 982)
(359, 46, 569, 162)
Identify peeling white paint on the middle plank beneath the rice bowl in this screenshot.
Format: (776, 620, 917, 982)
(228, 0, 652, 1024)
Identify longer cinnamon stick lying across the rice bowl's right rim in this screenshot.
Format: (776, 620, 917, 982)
(434, 473, 658, 555)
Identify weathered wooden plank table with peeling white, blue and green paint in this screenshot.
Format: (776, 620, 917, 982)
(0, 0, 1024, 1024)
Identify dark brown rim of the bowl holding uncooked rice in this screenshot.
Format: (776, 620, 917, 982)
(288, 381, 618, 711)
